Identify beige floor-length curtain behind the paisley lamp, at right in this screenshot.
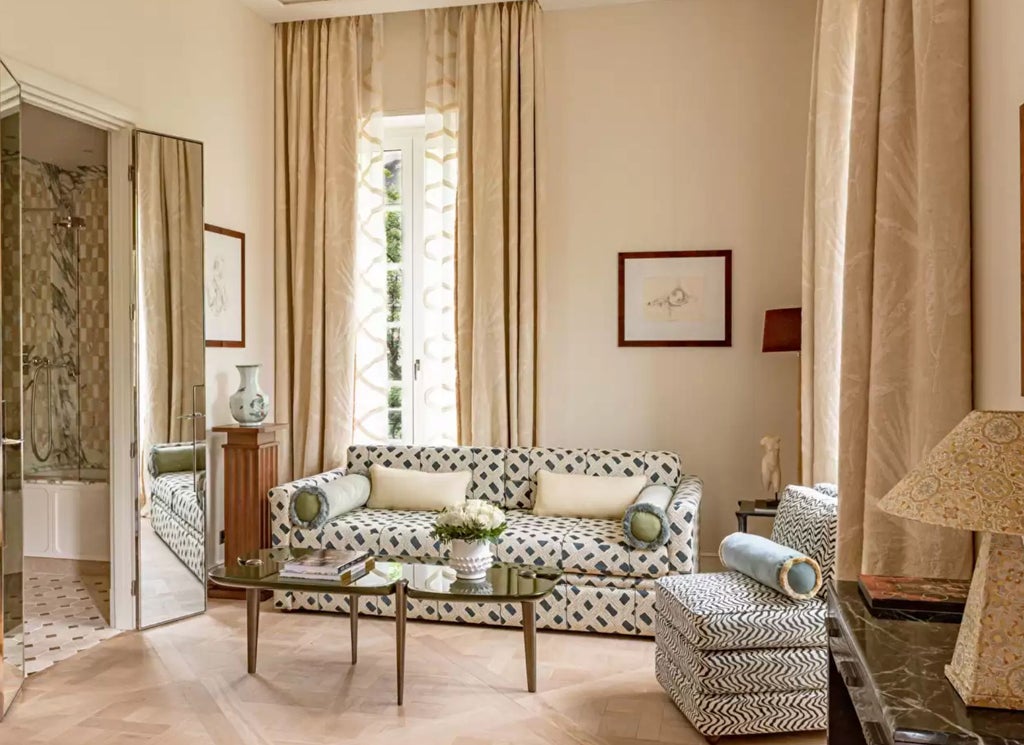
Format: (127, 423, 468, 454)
(803, 0, 973, 579)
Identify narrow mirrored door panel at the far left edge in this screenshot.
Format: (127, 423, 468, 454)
(0, 62, 25, 717)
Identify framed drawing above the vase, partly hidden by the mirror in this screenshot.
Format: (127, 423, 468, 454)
(203, 225, 246, 347)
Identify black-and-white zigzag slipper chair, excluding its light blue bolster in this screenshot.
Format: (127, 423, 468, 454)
(654, 486, 838, 737)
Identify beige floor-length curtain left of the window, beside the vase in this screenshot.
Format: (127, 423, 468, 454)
(275, 15, 383, 478)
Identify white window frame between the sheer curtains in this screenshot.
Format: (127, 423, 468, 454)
(384, 115, 426, 444)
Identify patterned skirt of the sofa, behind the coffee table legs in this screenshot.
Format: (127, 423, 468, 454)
(273, 574, 654, 637)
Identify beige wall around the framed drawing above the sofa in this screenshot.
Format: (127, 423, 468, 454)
(540, 0, 815, 565)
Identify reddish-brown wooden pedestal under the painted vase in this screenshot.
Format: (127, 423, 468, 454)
(208, 424, 286, 600)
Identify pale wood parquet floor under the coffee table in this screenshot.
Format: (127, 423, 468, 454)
(0, 601, 824, 745)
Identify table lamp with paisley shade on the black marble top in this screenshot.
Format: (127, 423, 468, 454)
(879, 411, 1024, 709)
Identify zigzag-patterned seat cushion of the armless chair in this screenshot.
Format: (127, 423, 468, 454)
(655, 572, 826, 650)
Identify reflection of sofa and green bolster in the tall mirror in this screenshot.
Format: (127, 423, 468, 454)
(146, 442, 206, 582)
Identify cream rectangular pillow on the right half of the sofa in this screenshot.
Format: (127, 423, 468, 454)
(532, 471, 647, 520)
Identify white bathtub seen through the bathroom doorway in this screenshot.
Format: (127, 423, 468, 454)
(23, 476, 111, 562)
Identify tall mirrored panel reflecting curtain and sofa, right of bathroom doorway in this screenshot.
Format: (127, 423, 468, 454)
(133, 131, 209, 628)
